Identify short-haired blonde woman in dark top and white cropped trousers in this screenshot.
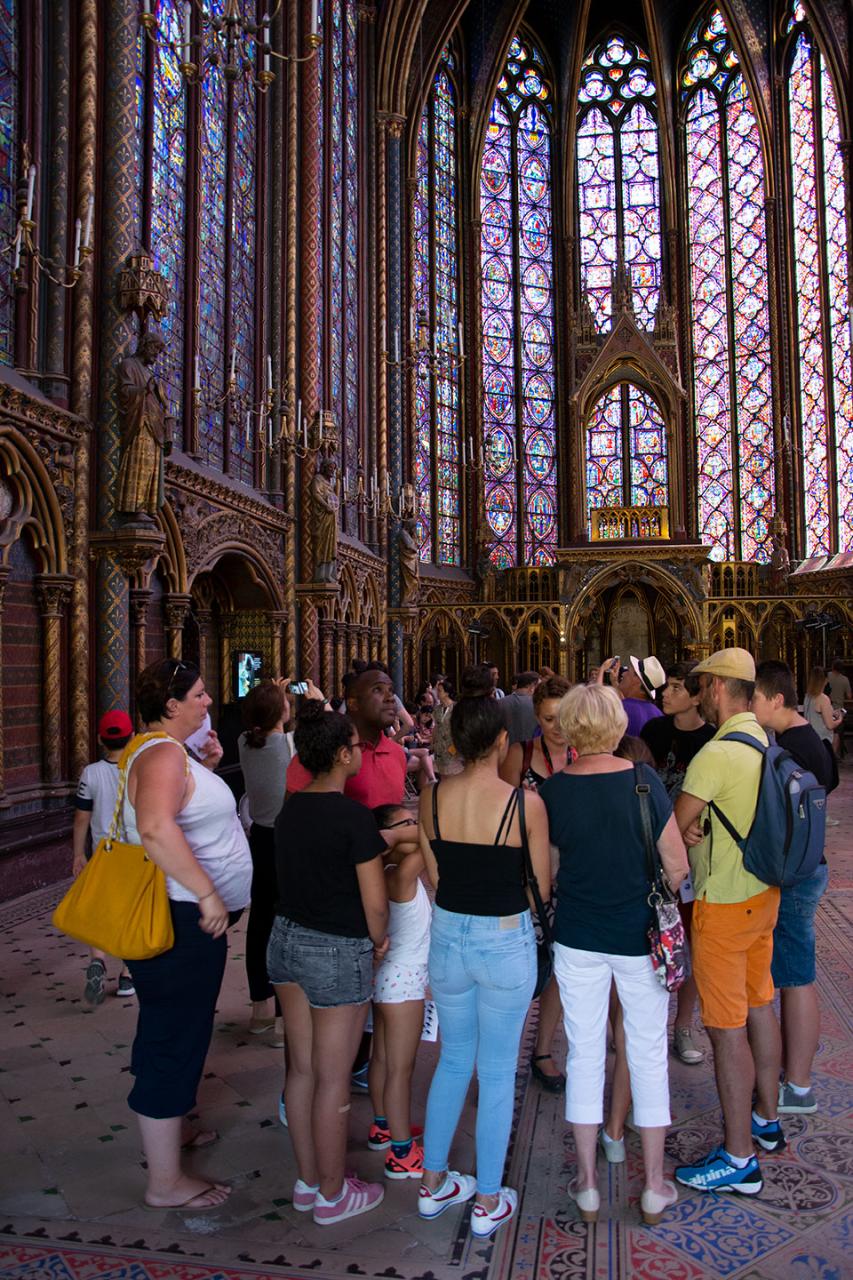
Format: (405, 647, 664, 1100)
(540, 685, 688, 1224)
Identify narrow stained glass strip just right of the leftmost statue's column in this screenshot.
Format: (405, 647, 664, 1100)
(148, 0, 187, 419)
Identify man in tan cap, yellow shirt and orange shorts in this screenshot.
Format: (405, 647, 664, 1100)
(675, 648, 785, 1196)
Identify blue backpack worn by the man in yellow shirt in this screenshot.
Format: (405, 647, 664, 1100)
(711, 733, 826, 888)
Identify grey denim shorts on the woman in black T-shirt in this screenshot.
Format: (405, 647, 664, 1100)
(266, 915, 373, 1009)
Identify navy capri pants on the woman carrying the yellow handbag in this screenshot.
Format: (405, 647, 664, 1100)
(127, 902, 233, 1120)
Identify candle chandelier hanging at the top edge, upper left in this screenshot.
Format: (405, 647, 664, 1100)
(140, 0, 323, 93)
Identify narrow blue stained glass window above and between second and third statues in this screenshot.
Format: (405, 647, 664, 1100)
(323, 0, 360, 532)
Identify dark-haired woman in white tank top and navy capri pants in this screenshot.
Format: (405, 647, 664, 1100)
(123, 659, 252, 1211)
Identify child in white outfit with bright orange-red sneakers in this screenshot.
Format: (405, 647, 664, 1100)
(368, 805, 432, 1179)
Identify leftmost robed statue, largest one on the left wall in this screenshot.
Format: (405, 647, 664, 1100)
(115, 330, 174, 524)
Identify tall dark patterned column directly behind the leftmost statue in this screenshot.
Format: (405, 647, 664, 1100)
(97, 0, 140, 714)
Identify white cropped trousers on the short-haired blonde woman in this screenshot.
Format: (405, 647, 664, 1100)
(553, 942, 670, 1128)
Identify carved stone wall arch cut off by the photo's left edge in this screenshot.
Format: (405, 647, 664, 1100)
(0, 425, 68, 573)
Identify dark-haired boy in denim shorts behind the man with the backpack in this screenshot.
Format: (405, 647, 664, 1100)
(752, 660, 838, 1115)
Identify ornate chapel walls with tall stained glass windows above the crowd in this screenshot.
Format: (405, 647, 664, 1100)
(0, 0, 853, 896)
